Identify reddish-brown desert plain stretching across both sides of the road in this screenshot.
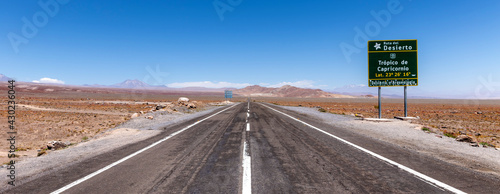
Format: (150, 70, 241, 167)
(0, 83, 500, 163)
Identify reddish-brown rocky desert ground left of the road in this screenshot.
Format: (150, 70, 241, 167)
(0, 84, 234, 164)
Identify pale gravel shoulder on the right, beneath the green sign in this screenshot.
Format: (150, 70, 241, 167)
(280, 106, 500, 177)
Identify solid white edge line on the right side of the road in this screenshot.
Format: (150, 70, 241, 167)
(261, 104, 465, 193)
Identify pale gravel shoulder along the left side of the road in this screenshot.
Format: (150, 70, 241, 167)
(0, 106, 225, 188)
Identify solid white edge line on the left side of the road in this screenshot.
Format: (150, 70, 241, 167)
(51, 104, 237, 194)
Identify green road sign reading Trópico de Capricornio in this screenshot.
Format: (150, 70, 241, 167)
(368, 40, 418, 87)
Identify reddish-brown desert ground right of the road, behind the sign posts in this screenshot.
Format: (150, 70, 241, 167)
(254, 98, 500, 148)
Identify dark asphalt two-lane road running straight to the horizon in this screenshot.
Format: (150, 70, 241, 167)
(7, 102, 500, 193)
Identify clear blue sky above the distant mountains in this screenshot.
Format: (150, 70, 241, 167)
(0, 0, 500, 98)
